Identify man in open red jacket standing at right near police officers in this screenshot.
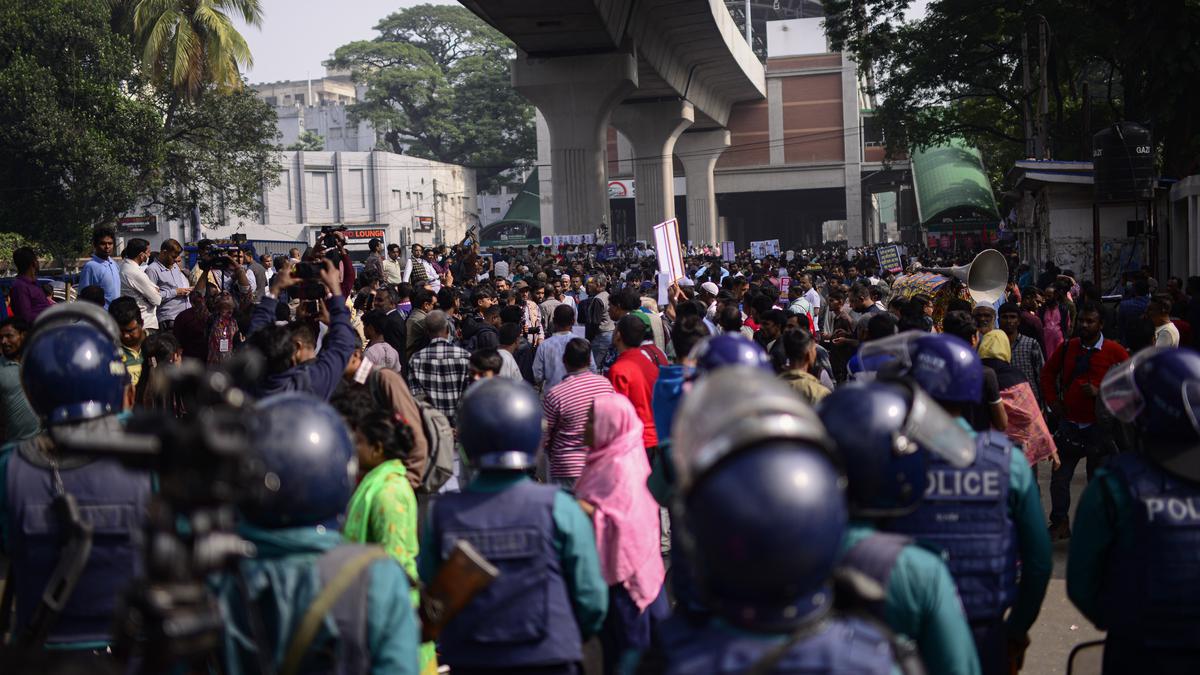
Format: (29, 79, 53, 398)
(1042, 303, 1129, 540)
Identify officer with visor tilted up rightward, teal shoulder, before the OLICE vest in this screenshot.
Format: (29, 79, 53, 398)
(818, 382, 979, 675)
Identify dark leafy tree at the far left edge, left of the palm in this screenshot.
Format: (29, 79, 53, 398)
(0, 0, 162, 256)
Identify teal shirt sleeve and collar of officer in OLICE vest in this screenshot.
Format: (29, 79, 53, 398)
(956, 418, 1054, 639)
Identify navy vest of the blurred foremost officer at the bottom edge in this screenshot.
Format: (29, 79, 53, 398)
(661, 616, 895, 675)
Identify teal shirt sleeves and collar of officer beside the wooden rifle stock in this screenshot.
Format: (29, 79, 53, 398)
(416, 471, 608, 639)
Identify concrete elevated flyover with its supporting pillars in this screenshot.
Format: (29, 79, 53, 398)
(460, 0, 767, 240)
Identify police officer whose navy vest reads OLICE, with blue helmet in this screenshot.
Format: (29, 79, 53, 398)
(888, 334, 1051, 674)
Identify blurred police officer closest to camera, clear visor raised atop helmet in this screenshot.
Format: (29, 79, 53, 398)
(661, 368, 908, 675)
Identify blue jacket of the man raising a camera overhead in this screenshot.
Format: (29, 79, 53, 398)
(247, 295, 355, 401)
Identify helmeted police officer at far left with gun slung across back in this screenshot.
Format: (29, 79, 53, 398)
(0, 303, 151, 663)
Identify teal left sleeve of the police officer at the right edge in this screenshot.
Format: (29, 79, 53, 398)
(1067, 468, 1134, 631)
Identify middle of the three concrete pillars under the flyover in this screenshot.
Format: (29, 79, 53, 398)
(612, 101, 695, 241)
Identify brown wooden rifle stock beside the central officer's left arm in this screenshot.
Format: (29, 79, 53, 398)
(420, 539, 500, 643)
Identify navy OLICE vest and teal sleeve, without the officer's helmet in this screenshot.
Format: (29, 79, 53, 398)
(888, 418, 1052, 673)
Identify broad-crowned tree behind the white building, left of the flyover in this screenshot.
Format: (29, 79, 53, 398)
(326, 5, 536, 190)
